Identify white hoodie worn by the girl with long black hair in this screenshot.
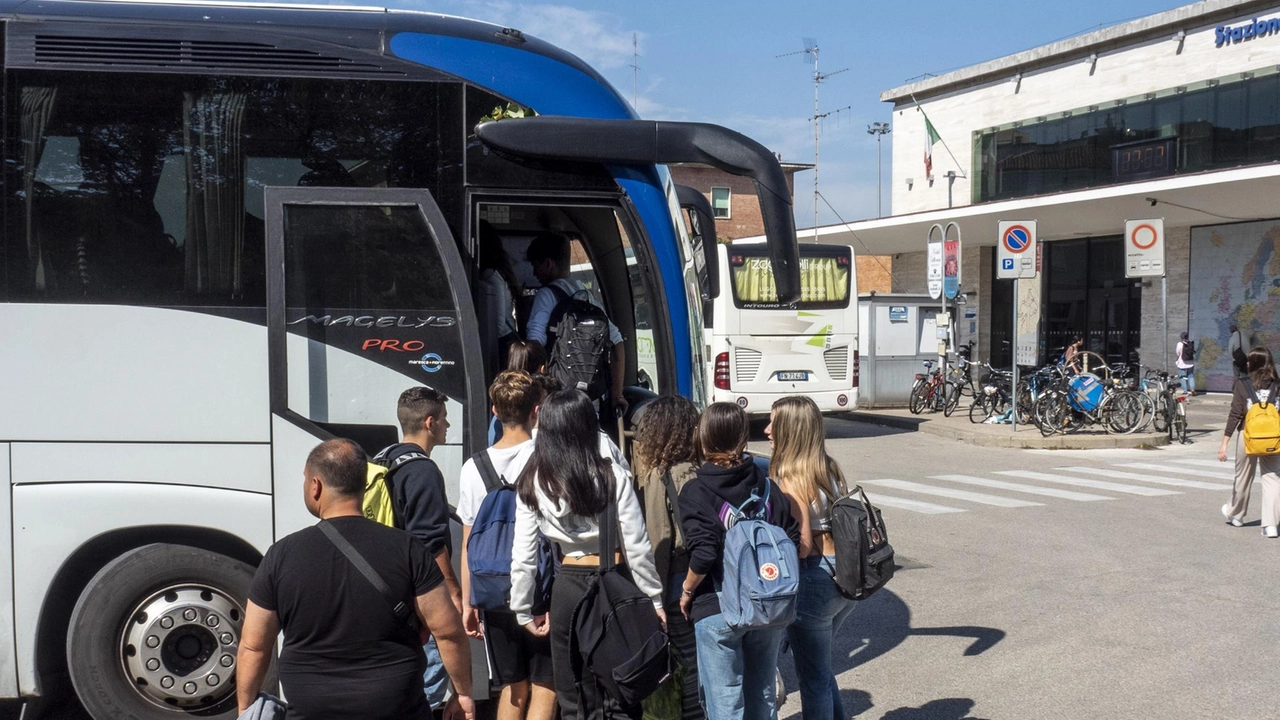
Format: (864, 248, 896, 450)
(511, 464, 662, 625)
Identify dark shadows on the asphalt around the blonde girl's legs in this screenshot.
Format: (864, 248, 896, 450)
(780, 589, 1006, 720)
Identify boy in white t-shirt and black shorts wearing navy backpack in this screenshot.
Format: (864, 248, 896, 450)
(458, 370, 556, 720)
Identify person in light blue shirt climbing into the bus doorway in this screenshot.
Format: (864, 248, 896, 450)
(525, 232, 627, 417)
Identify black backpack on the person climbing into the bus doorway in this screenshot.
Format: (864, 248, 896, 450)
(547, 283, 611, 400)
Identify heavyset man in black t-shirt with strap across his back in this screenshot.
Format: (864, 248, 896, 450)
(236, 439, 475, 720)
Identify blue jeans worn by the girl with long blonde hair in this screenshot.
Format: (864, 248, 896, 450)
(787, 555, 856, 720)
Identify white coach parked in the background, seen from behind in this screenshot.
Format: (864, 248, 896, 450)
(707, 242, 858, 416)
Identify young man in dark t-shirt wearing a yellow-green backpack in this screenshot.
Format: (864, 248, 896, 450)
(378, 386, 462, 710)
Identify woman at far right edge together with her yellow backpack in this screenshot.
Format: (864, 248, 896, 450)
(1217, 347, 1280, 538)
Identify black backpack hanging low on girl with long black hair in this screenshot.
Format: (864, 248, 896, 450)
(568, 498, 671, 708)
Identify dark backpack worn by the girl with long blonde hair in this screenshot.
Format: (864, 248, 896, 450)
(831, 487, 895, 600)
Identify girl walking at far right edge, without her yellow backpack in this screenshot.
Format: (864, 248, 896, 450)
(1217, 347, 1280, 538)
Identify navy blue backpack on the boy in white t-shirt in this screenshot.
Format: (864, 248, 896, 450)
(467, 450, 556, 615)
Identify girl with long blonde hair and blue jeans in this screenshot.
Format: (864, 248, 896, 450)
(764, 395, 854, 720)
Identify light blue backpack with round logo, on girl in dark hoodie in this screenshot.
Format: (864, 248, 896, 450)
(721, 480, 800, 630)
